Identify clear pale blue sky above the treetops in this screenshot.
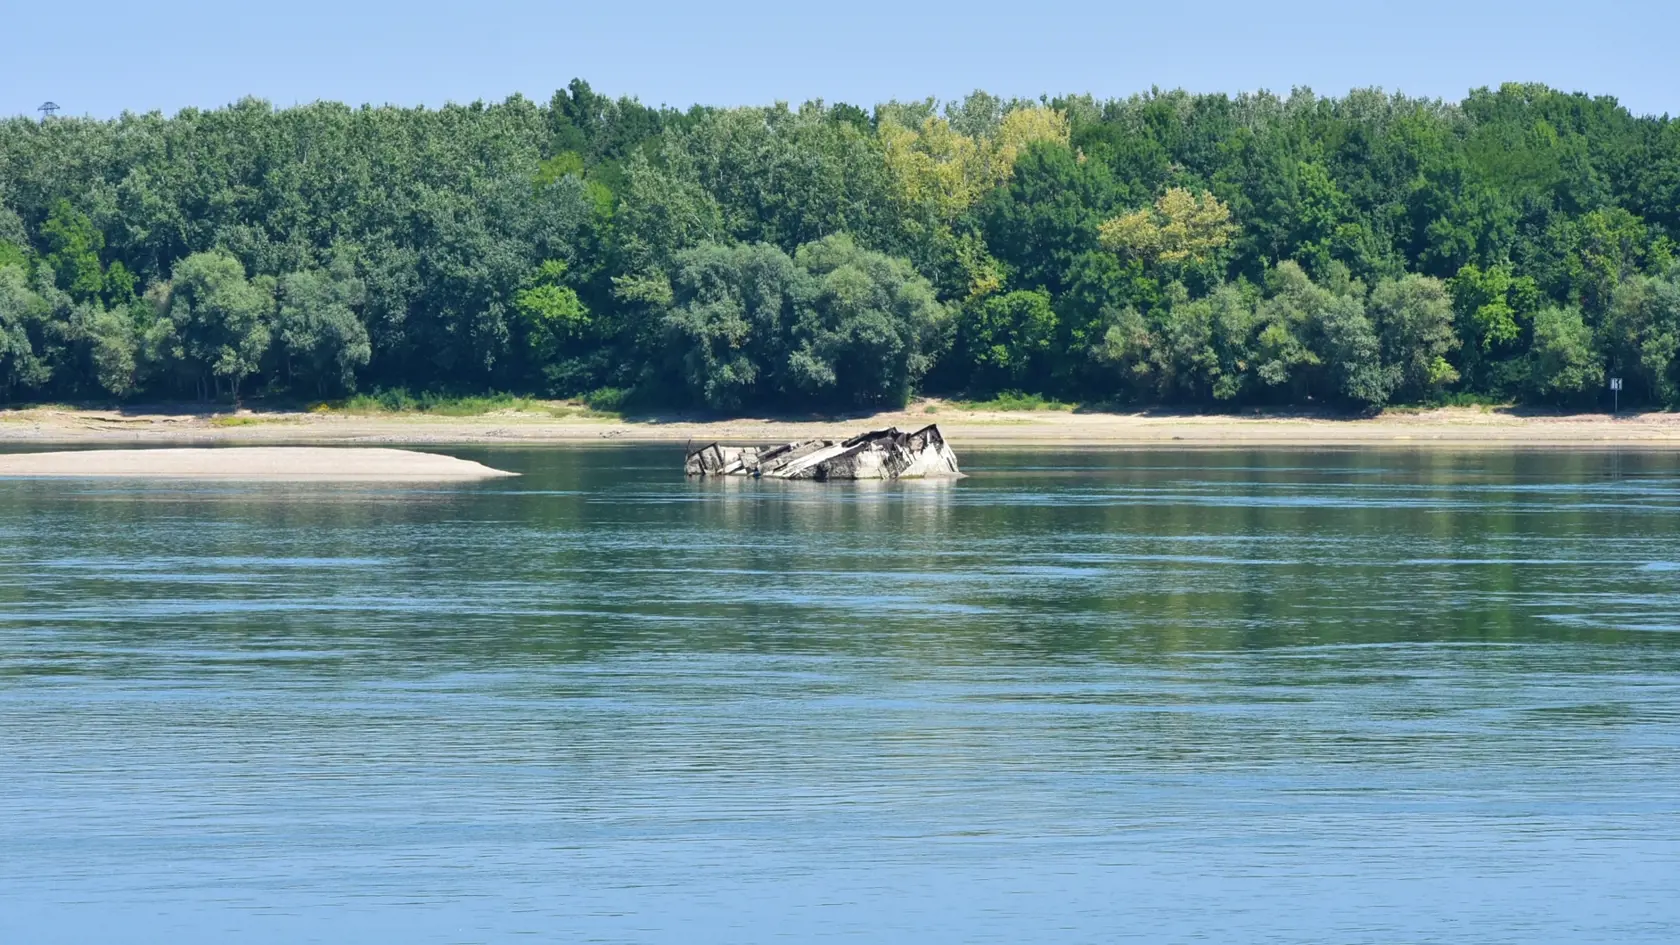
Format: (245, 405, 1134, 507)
(13, 0, 1680, 116)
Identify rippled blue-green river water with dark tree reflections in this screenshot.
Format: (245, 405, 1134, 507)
(0, 447, 1680, 943)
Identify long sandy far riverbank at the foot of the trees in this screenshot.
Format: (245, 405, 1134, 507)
(0, 400, 1680, 449)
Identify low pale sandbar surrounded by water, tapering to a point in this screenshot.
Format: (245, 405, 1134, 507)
(0, 446, 517, 483)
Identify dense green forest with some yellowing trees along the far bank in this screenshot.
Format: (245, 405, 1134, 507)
(0, 81, 1680, 412)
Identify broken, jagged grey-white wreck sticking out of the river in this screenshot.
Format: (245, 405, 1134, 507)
(682, 424, 963, 483)
